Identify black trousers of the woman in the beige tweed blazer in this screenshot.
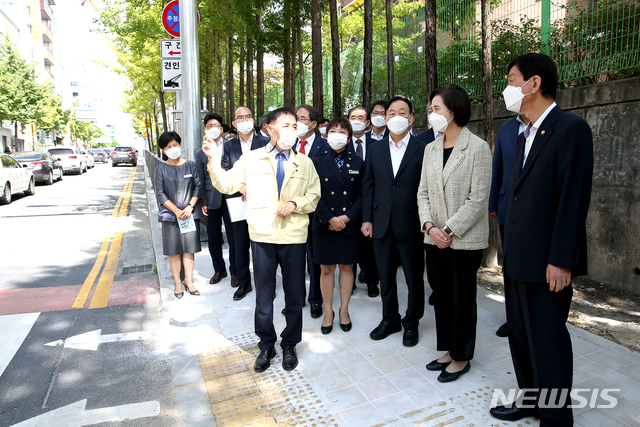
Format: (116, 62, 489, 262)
(427, 245, 482, 361)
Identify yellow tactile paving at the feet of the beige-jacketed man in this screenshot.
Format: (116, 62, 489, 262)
(200, 334, 337, 427)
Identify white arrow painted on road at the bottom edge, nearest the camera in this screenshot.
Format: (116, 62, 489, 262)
(13, 399, 160, 427)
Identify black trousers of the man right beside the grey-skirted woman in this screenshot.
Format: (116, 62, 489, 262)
(207, 200, 236, 275)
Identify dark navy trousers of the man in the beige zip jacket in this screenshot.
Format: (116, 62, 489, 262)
(251, 242, 305, 351)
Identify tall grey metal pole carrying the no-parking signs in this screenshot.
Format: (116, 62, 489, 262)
(180, 0, 202, 160)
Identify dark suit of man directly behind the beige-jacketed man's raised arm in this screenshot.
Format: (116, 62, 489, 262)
(220, 133, 271, 286)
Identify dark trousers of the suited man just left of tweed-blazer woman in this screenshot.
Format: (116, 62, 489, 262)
(373, 231, 424, 330)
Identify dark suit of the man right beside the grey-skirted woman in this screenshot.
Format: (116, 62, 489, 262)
(196, 149, 236, 276)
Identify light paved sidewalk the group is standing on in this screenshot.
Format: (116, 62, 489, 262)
(147, 162, 640, 427)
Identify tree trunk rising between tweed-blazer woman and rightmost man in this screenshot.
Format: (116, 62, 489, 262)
(482, 0, 500, 267)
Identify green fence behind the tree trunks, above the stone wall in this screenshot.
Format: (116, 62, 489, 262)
(265, 0, 640, 117)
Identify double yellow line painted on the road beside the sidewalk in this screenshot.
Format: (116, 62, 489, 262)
(72, 168, 137, 308)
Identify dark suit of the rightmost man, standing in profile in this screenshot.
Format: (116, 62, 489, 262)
(504, 106, 593, 427)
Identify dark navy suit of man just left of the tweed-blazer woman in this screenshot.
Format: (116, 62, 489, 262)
(362, 136, 426, 330)
